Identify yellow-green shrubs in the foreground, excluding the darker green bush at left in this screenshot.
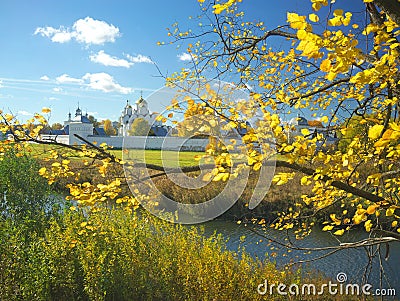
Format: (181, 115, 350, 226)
(0, 209, 299, 300)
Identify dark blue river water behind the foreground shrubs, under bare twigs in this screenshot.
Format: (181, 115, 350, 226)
(202, 220, 400, 290)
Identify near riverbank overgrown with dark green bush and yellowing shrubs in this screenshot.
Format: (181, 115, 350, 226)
(0, 145, 388, 301)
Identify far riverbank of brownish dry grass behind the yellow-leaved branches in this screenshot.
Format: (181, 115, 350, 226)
(40, 157, 310, 220)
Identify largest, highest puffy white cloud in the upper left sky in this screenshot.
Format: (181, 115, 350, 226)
(34, 17, 121, 45)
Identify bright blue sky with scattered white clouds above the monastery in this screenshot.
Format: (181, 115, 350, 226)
(0, 0, 362, 123)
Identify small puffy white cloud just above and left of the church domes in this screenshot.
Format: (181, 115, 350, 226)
(82, 72, 133, 94)
